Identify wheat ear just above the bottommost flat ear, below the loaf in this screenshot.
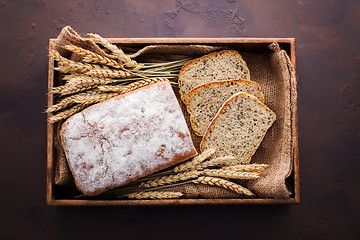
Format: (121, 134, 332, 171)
(140, 171, 201, 187)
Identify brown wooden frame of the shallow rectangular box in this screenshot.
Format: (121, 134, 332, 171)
(46, 38, 300, 206)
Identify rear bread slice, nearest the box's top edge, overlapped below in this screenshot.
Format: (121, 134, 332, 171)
(179, 50, 250, 104)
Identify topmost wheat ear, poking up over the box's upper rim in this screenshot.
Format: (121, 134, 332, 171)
(88, 33, 139, 68)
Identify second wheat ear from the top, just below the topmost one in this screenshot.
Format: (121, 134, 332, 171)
(65, 45, 124, 68)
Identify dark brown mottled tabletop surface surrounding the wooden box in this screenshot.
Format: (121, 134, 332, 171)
(0, 0, 360, 239)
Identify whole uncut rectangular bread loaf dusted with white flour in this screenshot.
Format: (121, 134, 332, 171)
(60, 81, 197, 195)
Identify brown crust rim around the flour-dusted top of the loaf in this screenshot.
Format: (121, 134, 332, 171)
(60, 81, 198, 196)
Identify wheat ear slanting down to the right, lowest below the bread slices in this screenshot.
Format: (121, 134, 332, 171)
(193, 177, 254, 196)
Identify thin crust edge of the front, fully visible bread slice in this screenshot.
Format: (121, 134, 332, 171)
(200, 92, 276, 164)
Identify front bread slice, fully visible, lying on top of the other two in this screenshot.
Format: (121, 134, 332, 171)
(200, 92, 276, 164)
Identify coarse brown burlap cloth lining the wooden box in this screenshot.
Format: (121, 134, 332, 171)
(55, 27, 297, 198)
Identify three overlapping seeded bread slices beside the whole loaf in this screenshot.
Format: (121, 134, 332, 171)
(179, 50, 276, 164)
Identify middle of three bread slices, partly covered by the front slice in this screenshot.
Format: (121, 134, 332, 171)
(187, 80, 264, 136)
